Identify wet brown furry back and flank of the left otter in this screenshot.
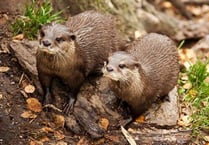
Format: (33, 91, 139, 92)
(66, 11, 123, 74)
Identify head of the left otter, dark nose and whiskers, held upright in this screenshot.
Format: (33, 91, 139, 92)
(39, 23, 76, 55)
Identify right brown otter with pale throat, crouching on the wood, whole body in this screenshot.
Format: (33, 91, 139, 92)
(102, 33, 179, 116)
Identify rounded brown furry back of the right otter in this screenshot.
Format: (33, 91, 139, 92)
(128, 33, 179, 96)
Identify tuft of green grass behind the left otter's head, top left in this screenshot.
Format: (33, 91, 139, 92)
(12, 0, 63, 39)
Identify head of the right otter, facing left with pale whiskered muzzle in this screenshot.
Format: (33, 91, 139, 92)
(102, 51, 141, 82)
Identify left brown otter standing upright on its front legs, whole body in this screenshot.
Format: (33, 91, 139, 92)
(37, 11, 122, 113)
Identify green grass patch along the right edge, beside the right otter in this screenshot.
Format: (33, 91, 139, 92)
(179, 60, 209, 142)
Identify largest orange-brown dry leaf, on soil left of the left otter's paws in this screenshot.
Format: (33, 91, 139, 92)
(26, 98, 42, 112)
